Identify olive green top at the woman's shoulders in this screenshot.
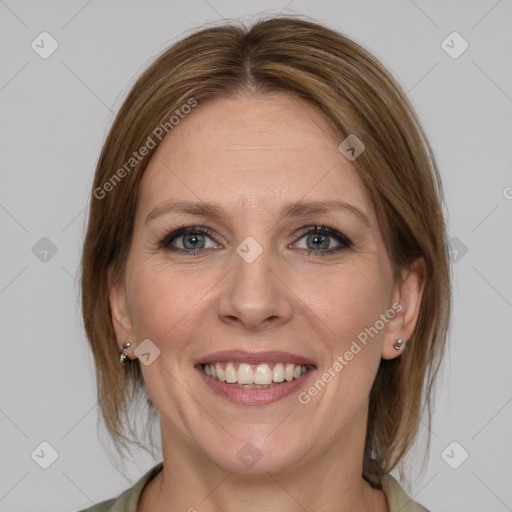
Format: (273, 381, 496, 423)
(76, 462, 429, 512)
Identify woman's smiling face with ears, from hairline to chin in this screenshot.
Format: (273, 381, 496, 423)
(111, 94, 421, 472)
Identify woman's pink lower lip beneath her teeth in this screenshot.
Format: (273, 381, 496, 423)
(196, 365, 315, 405)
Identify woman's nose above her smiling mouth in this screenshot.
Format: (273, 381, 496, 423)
(217, 243, 294, 332)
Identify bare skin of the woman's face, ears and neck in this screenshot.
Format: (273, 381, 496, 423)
(110, 94, 425, 512)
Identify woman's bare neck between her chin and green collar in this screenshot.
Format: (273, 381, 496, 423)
(137, 414, 389, 512)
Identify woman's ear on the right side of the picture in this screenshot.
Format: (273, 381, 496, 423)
(381, 257, 427, 359)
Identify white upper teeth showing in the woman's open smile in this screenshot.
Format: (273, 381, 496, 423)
(203, 362, 307, 384)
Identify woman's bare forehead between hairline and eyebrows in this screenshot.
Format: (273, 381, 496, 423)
(139, 94, 373, 223)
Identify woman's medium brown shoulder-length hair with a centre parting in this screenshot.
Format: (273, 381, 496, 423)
(81, 16, 451, 487)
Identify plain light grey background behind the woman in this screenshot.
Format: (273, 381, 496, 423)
(0, 0, 512, 512)
